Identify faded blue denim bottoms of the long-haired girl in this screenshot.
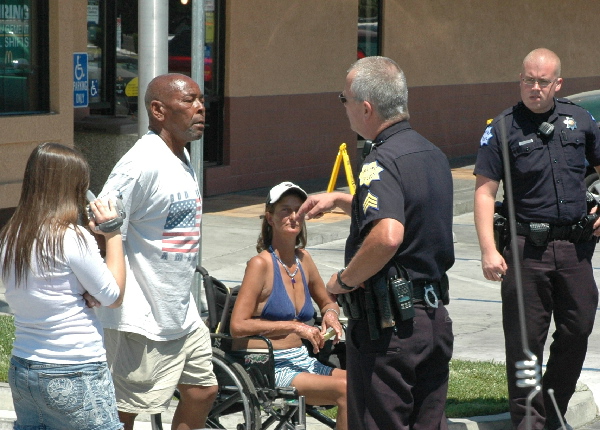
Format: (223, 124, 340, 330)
(8, 355, 123, 430)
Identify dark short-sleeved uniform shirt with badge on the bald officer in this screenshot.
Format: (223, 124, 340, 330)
(474, 99, 600, 225)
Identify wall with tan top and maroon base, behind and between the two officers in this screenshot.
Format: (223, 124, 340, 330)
(383, 0, 600, 161)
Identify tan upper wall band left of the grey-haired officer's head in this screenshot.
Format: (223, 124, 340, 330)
(225, 0, 358, 97)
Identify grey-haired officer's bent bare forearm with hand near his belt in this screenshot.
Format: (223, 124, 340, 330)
(327, 218, 404, 294)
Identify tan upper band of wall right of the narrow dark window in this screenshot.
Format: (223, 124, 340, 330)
(383, 0, 600, 86)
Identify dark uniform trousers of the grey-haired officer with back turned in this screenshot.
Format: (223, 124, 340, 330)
(346, 303, 454, 430)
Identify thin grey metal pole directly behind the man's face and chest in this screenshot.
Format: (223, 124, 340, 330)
(190, 0, 208, 316)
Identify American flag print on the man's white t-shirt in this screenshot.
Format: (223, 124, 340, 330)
(162, 193, 202, 253)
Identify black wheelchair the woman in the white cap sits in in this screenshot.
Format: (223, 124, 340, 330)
(152, 266, 346, 430)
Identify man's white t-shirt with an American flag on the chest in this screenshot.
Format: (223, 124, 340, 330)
(97, 132, 202, 341)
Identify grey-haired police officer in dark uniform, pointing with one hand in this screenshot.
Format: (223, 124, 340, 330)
(298, 57, 454, 430)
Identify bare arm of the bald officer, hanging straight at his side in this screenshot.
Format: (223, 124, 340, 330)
(474, 175, 507, 281)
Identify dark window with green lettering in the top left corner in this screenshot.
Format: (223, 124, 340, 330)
(0, 0, 50, 115)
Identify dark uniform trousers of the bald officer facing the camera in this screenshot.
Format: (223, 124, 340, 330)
(502, 236, 598, 429)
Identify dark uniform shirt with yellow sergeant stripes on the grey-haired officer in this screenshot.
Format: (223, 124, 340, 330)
(346, 121, 454, 281)
